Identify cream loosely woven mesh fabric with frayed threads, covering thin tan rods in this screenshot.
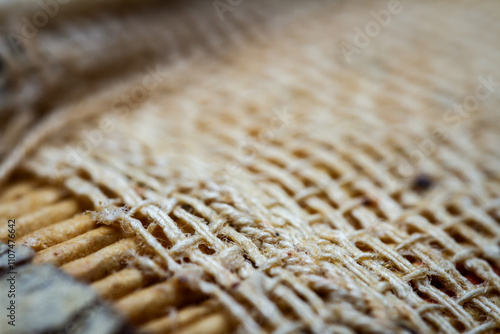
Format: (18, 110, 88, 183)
(0, 1, 500, 333)
